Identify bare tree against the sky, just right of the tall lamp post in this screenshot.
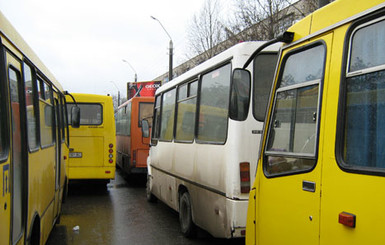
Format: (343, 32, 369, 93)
(188, 0, 225, 60)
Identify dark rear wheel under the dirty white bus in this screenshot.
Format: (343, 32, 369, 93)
(179, 191, 196, 238)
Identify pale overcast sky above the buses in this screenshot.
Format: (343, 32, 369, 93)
(0, 0, 231, 95)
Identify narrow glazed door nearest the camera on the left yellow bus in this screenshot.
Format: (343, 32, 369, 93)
(6, 52, 28, 244)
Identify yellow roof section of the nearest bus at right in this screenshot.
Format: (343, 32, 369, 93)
(288, 0, 385, 43)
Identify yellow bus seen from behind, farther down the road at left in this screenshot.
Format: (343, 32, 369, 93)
(67, 93, 116, 182)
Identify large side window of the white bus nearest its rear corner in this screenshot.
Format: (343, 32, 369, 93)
(197, 64, 231, 143)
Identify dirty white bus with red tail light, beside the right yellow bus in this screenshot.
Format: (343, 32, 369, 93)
(147, 42, 280, 238)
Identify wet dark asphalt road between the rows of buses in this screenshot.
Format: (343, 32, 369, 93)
(47, 171, 244, 245)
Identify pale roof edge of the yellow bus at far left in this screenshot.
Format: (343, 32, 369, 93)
(0, 11, 63, 91)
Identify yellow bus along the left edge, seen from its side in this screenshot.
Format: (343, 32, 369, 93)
(0, 9, 76, 244)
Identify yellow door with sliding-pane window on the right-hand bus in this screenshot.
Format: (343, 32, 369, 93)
(256, 34, 332, 245)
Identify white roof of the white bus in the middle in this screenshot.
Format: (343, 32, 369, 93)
(156, 41, 282, 94)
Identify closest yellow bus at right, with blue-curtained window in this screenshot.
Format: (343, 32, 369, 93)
(246, 0, 385, 245)
